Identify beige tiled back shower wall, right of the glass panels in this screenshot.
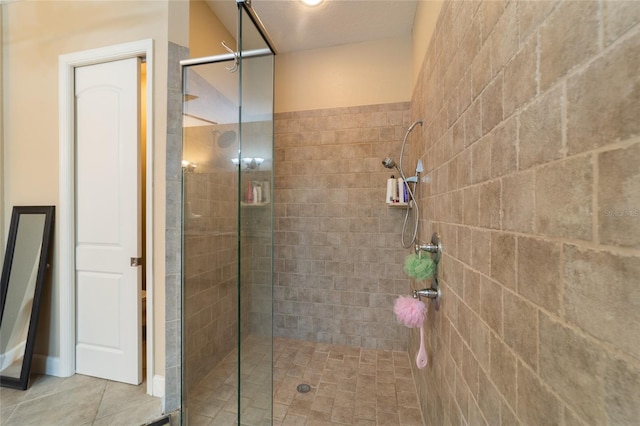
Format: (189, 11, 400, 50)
(274, 103, 416, 350)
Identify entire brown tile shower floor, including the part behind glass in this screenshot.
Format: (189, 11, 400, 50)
(188, 336, 423, 426)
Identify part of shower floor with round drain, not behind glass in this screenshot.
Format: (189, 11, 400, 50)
(273, 338, 423, 426)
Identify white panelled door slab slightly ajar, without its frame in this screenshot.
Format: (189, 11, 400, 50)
(75, 58, 142, 385)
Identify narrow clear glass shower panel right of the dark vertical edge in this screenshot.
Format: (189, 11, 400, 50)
(238, 3, 274, 425)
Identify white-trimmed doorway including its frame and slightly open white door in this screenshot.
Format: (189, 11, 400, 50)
(58, 40, 154, 394)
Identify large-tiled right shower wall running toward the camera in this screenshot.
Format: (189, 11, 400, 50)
(409, 1, 640, 425)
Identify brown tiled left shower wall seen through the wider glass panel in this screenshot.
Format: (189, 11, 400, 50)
(183, 173, 238, 390)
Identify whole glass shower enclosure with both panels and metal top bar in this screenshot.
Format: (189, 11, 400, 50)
(181, 1, 275, 425)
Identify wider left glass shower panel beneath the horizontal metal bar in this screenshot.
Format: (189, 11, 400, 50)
(182, 62, 240, 424)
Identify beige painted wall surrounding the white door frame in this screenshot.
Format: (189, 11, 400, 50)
(2, 1, 169, 382)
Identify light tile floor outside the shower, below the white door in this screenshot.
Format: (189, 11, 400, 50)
(0, 374, 162, 426)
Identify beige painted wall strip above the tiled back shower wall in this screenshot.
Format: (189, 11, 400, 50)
(275, 37, 411, 112)
